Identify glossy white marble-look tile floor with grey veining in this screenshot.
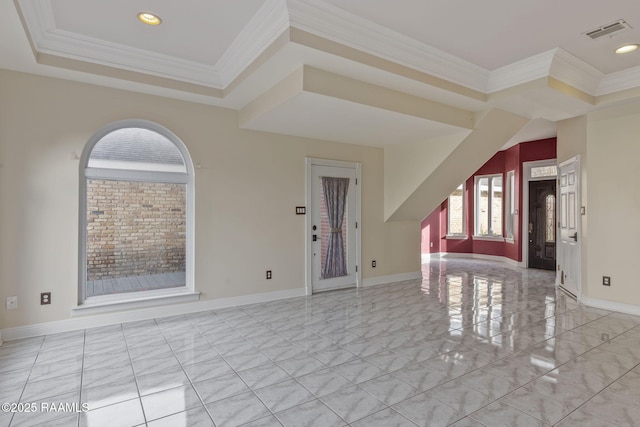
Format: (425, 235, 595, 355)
(0, 259, 640, 427)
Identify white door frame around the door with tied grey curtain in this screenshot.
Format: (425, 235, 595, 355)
(304, 157, 362, 295)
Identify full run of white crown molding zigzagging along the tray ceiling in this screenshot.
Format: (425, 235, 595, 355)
(16, 0, 640, 104)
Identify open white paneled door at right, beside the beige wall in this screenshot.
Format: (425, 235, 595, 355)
(557, 158, 582, 297)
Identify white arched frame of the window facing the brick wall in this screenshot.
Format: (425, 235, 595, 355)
(72, 119, 200, 316)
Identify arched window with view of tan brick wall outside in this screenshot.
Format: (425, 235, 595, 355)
(78, 120, 193, 305)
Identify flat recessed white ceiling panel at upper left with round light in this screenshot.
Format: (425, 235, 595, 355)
(47, 0, 264, 66)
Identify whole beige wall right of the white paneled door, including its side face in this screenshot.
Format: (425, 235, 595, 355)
(558, 103, 640, 312)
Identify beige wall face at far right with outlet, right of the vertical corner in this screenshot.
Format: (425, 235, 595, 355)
(586, 103, 640, 306)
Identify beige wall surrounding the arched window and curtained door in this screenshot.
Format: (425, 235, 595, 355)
(0, 71, 420, 328)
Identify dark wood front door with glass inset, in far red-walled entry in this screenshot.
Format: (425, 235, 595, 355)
(529, 179, 556, 270)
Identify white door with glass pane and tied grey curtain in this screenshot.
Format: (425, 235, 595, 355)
(307, 162, 359, 292)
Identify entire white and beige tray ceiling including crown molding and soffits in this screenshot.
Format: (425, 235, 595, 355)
(0, 0, 640, 146)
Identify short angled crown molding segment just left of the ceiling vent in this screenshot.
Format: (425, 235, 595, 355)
(487, 49, 556, 93)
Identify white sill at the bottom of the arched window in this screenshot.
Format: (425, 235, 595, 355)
(71, 288, 200, 317)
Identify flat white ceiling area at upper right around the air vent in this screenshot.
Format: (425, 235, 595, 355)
(325, 0, 640, 73)
